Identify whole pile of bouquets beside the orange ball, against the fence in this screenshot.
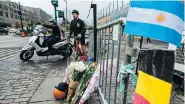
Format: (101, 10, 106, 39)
(64, 61, 99, 104)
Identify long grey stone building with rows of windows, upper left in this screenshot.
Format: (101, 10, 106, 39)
(0, 0, 51, 28)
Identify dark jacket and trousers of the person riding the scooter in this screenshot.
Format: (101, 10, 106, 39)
(43, 24, 61, 52)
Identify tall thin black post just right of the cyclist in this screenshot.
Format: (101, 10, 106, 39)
(91, 4, 97, 61)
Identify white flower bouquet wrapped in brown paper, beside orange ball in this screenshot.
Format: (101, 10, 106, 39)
(64, 61, 87, 101)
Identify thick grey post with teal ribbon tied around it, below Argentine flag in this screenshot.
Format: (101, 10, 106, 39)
(123, 35, 134, 104)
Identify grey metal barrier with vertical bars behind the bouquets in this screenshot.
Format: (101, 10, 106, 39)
(97, 19, 134, 104)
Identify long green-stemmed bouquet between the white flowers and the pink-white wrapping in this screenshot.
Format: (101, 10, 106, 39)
(70, 63, 98, 104)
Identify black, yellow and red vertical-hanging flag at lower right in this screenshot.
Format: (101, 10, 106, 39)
(133, 49, 175, 104)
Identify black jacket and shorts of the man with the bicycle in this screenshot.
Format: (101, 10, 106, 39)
(69, 18, 86, 45)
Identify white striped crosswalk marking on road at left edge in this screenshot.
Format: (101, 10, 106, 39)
(0, 49, 21, 61)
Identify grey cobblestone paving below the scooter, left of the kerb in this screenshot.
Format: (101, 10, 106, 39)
(0, 55, 66, 104)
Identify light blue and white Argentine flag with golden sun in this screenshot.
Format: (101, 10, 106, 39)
(124, 0, 184, 46)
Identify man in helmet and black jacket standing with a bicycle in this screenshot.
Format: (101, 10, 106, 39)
(69, 10, 86, 54)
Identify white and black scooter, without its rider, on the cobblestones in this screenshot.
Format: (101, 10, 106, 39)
(20, 29, 73, 61)
